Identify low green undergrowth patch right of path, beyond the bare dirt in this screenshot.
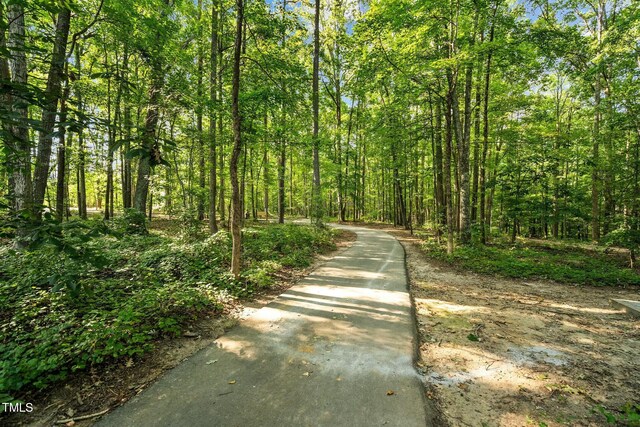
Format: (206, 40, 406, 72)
(422, 240, 640, 286)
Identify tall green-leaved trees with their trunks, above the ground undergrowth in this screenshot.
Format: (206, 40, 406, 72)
(0, 0, 640, 256)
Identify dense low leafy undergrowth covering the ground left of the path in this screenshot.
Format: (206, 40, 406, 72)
(0, 225, 333, 402)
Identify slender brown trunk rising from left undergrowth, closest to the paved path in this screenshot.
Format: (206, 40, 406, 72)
(229, 0, 244, 279)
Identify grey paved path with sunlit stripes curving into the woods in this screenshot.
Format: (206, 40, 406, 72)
(97, 227, 427, 427)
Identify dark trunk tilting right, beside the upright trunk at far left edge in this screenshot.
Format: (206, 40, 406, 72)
(33, 6, 71, 218)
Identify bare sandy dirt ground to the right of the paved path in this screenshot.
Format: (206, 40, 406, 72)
(364, 226, 640, 427)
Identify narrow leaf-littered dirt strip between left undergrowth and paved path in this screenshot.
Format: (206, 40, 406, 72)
(0, 230, 356, 427)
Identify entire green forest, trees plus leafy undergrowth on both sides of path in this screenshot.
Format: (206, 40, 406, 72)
(0, 0, 640, 424)
